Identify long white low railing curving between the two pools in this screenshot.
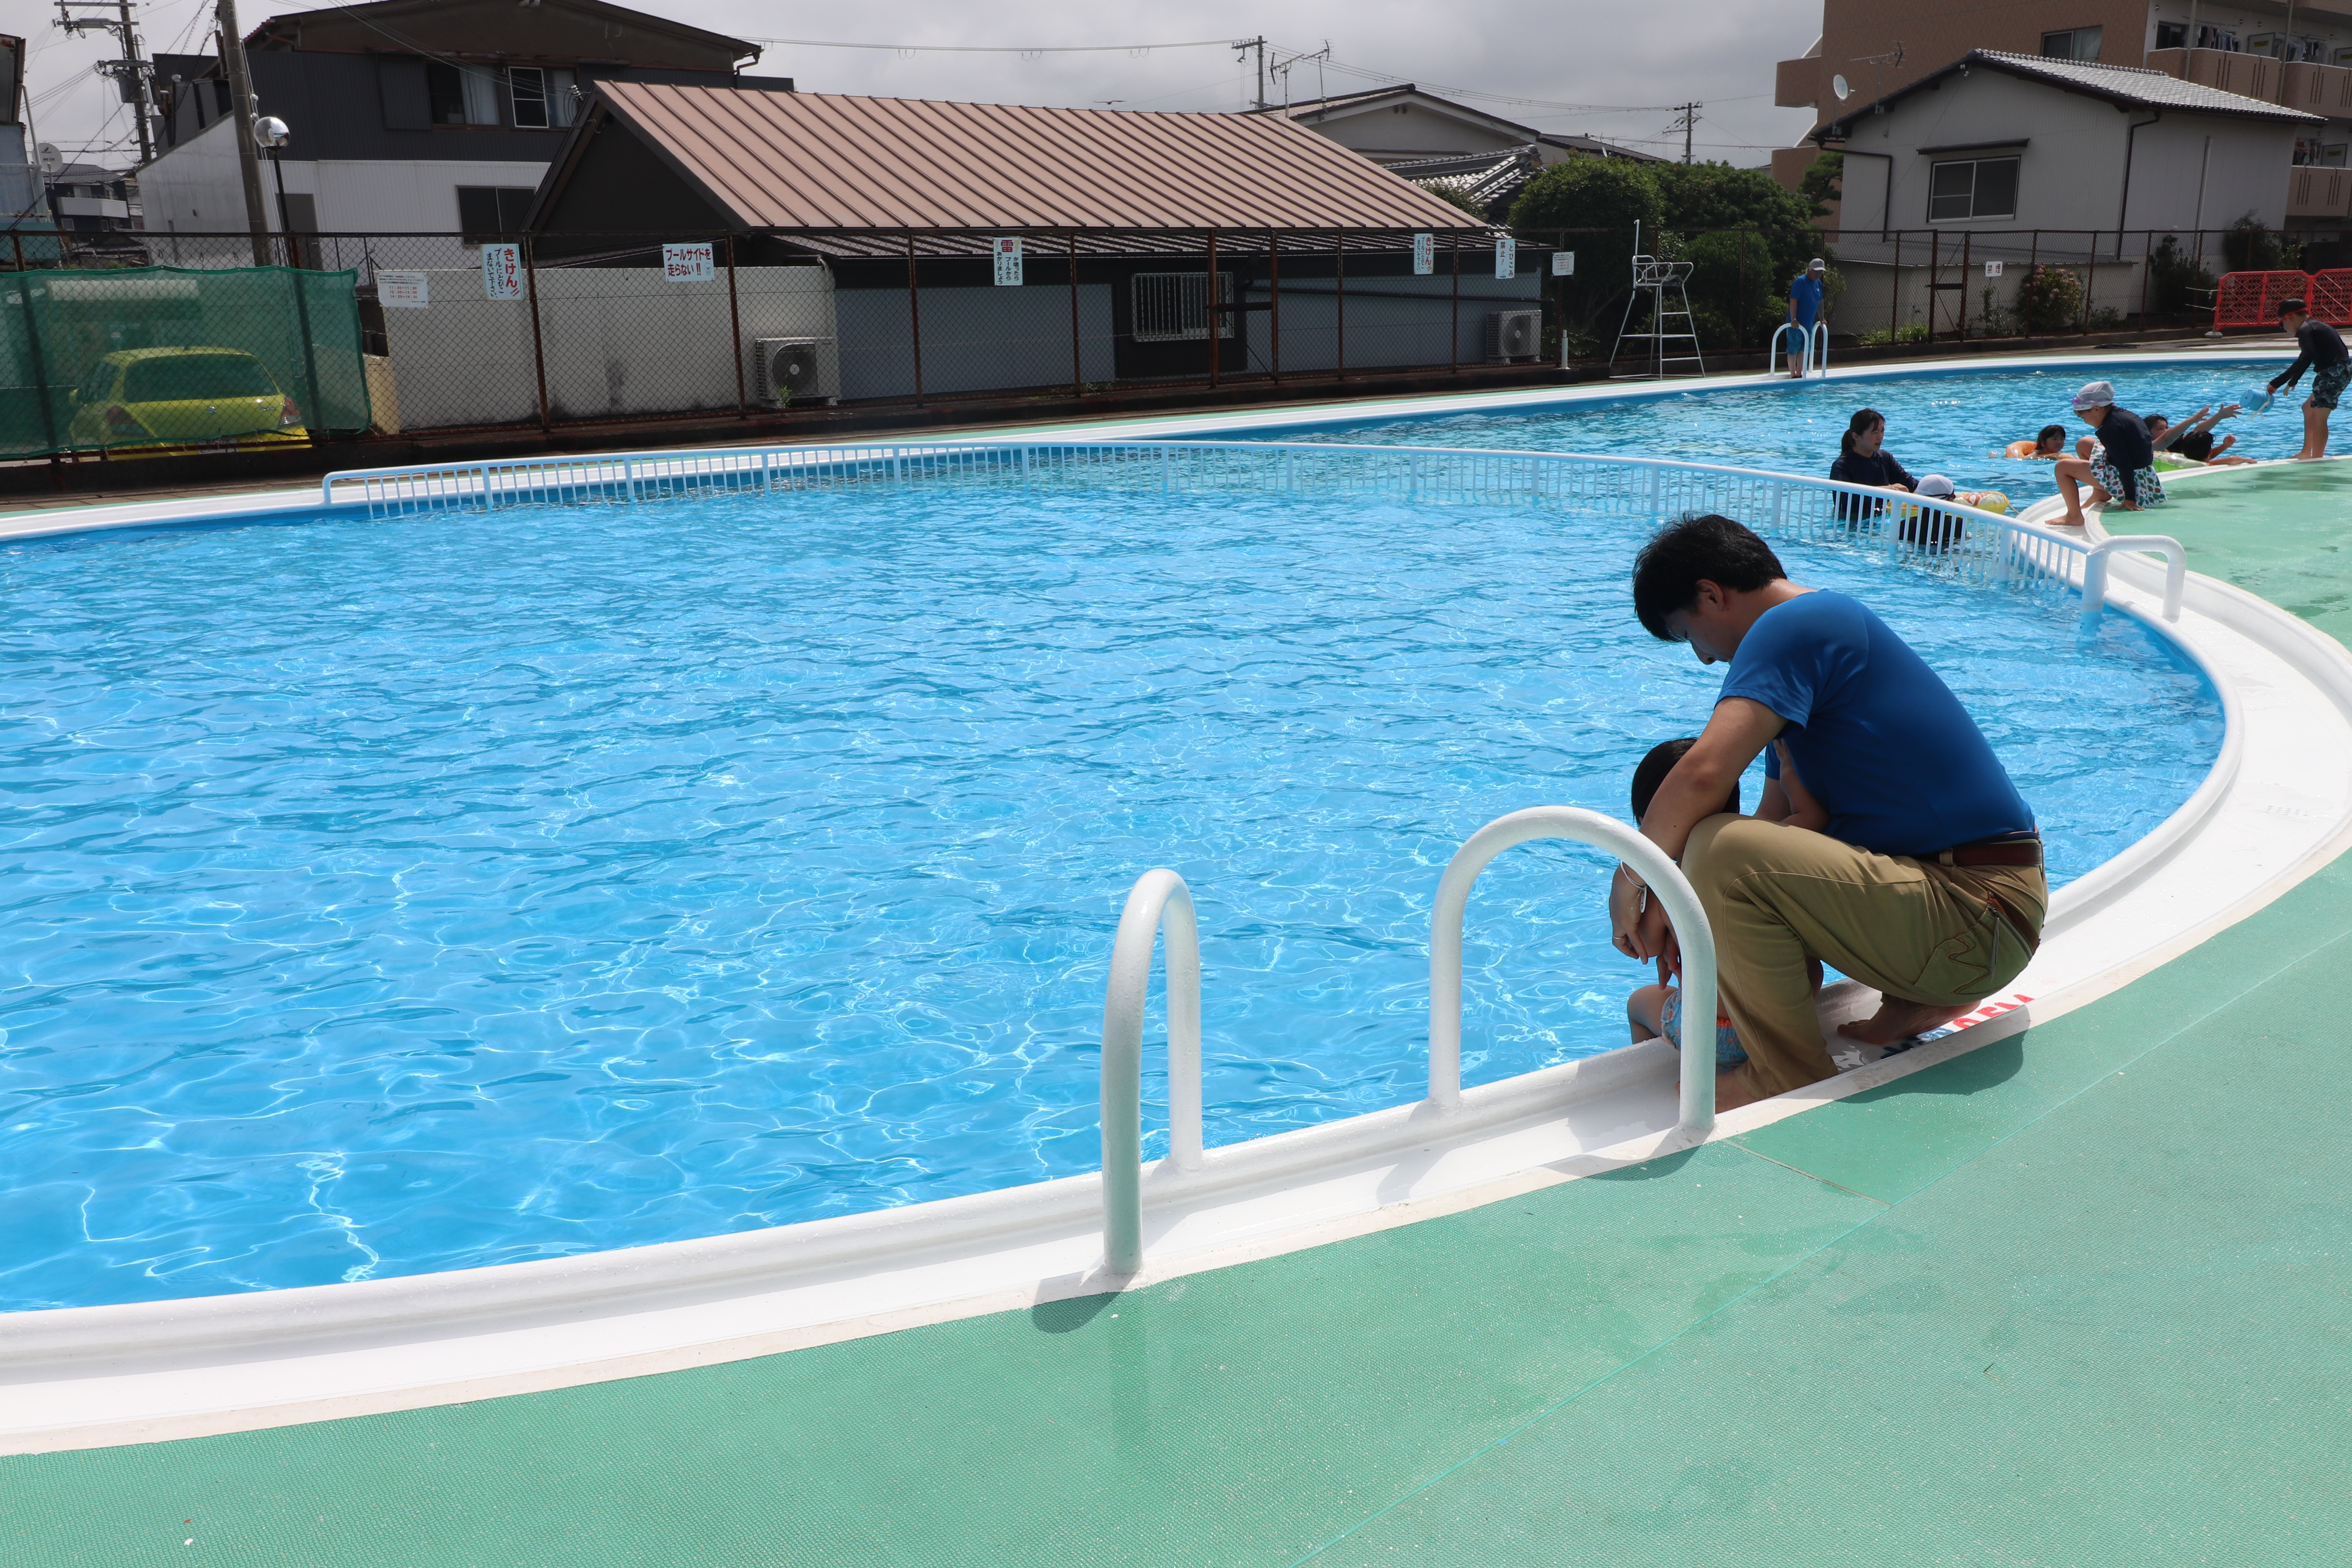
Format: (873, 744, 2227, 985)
(322, 442, 2185, 616)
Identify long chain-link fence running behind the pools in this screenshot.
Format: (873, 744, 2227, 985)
(0, 228, 2347, 458)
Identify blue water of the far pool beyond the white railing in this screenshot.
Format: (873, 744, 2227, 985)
(1247, 355, 2310, 510)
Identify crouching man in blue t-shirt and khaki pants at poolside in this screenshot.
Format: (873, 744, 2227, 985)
(1611, 517, 2049, 1110)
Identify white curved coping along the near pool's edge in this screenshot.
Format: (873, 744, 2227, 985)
(0, 360, 2352, 1450)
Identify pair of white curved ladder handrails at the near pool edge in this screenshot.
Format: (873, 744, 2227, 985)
(1101, 806, 1715, 1274)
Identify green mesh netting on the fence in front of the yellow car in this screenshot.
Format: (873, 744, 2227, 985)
(0, 266, 369, 458)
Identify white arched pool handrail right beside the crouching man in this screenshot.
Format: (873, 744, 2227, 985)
(1430, 806, 1715, 1138)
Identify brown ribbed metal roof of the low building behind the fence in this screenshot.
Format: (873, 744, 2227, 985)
(579, 82, 1484, 230)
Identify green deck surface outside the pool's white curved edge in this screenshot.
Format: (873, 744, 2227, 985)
(14, 472, 2352, 1568)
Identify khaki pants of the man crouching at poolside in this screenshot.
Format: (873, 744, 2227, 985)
(1682, 816, 2049, 1096)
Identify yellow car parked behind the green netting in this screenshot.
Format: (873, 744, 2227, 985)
(66, 348, 310, 451)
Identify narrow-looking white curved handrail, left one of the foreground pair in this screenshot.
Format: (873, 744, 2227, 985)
(1103, 867, 1200, 1274)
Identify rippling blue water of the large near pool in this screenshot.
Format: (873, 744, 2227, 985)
(0, 446, 2220, 1307)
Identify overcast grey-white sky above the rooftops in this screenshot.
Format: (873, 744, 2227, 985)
(9, 0, 1820, 167)
